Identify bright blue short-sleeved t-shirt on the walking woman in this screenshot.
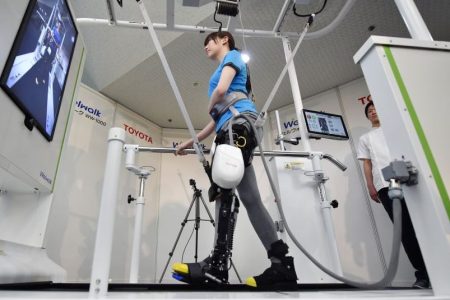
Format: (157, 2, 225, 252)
(208, 50, 258, 132)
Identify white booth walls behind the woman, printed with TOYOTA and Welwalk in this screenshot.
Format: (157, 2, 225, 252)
(46, 79, 413, 285)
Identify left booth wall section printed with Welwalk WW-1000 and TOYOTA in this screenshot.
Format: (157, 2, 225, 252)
(46, 85, 161, 282)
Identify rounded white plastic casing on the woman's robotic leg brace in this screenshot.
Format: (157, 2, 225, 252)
(212, 144, 245, 189)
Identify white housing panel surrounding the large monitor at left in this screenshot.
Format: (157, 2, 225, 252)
(0, 0, 85, 283)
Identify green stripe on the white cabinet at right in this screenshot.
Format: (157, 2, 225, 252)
(384, 46, 450, 220)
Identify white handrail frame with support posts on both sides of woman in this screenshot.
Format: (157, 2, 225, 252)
(89, 137, 346, 298)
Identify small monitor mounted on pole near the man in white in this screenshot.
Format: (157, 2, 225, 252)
(303, 109, 348, 140)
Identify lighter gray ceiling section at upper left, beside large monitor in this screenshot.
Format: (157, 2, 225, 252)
(71, 0, 213, 90)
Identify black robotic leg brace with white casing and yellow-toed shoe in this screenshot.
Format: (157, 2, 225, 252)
(172, 116, 256, 284)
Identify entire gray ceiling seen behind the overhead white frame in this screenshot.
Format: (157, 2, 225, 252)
(72, 0, 450, 128)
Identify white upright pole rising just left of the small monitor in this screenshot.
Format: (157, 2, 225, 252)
(282, 37, 311, 152)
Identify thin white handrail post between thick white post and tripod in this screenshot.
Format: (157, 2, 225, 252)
(130, 176, 147, 283)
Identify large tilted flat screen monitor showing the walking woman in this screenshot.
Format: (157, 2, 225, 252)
(0, 0, 78, 141)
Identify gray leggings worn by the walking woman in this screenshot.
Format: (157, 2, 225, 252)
(214, 165, 278, 250)
